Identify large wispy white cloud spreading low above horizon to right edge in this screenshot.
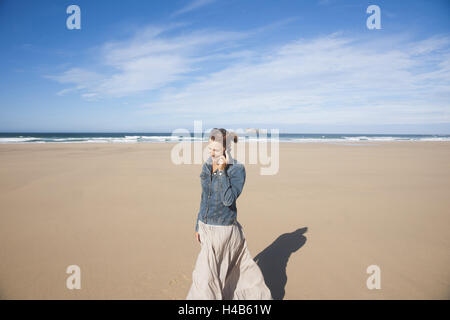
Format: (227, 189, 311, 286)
(137, 34, 450, 124)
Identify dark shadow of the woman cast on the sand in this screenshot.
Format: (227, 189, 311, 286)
(253, 227, 308, 300)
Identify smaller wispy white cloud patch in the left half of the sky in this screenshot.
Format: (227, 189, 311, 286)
(46, 26, 248, 100)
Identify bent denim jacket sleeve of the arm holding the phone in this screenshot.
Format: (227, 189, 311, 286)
(219, 165, 246, 207)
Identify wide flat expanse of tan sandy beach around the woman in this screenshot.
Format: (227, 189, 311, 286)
(0, 141, 450, 299)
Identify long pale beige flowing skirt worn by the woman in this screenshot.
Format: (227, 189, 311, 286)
(186, 221, 272, 300)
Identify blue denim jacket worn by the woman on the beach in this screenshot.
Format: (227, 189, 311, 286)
(195, 156, 245, 231)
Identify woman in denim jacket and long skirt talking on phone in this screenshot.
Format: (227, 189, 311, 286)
(186, 128, 272, 300)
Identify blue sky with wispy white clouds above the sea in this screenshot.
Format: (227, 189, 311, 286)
(0, 0, 450, 134)
